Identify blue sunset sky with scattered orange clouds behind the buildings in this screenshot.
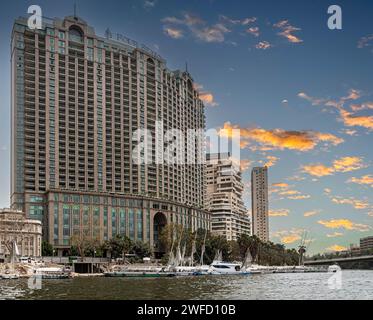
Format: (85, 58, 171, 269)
(0, 0, 373, 253)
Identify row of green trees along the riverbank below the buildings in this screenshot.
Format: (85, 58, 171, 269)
(42, 224, 299, 266)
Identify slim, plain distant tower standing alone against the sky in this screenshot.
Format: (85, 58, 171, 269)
(251, 167, 269, 242)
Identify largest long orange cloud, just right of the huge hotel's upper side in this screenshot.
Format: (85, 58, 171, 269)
(224, 122, 344, 152)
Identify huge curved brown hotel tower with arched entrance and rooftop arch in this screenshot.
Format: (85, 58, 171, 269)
(11, 16, 210, 254)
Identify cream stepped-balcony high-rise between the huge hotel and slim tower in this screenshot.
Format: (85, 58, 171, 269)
(206, 153, 251, 241)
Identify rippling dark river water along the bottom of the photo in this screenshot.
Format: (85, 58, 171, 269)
(0, 271, 373, 300)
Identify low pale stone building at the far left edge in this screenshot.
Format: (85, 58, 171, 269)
(0, 209, 42, 257)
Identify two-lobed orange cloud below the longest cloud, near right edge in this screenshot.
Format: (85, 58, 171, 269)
(302, 157, 366, 177)
